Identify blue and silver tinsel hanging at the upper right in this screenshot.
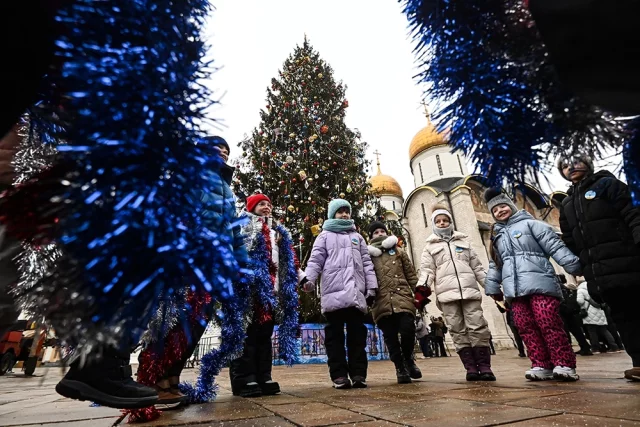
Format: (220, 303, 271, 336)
(401, 0, 620, 185)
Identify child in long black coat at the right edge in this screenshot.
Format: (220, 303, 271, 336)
(557, 154, 640, 381)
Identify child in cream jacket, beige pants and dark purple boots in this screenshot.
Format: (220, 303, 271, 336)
(418, 205, 496, 381)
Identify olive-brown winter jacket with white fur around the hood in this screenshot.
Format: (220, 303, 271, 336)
(368, 236, 418, 323)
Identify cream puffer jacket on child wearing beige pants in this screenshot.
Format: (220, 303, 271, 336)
(418, 231, 487, 303)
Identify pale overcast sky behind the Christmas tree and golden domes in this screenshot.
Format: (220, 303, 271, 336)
(206, 0, 624, 197)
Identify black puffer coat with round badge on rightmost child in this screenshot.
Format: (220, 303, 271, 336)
(560, 171, 640, 298)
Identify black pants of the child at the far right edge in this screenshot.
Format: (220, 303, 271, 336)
(602, 283, 640, 368)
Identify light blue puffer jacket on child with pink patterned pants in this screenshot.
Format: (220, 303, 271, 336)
(485, 210, 580, 298)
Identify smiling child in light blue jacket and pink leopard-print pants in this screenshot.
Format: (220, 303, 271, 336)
(484, 188, 581, 381)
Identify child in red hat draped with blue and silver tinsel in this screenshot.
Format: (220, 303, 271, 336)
(229, 193, 306, 397)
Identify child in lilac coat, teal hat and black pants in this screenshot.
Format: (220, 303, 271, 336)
(304, 199, 378, 389)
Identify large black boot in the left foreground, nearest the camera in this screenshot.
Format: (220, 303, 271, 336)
(56, 355, 158, 409)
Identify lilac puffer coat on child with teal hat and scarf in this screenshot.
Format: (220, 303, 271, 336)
(305, 229, 378, 313)
